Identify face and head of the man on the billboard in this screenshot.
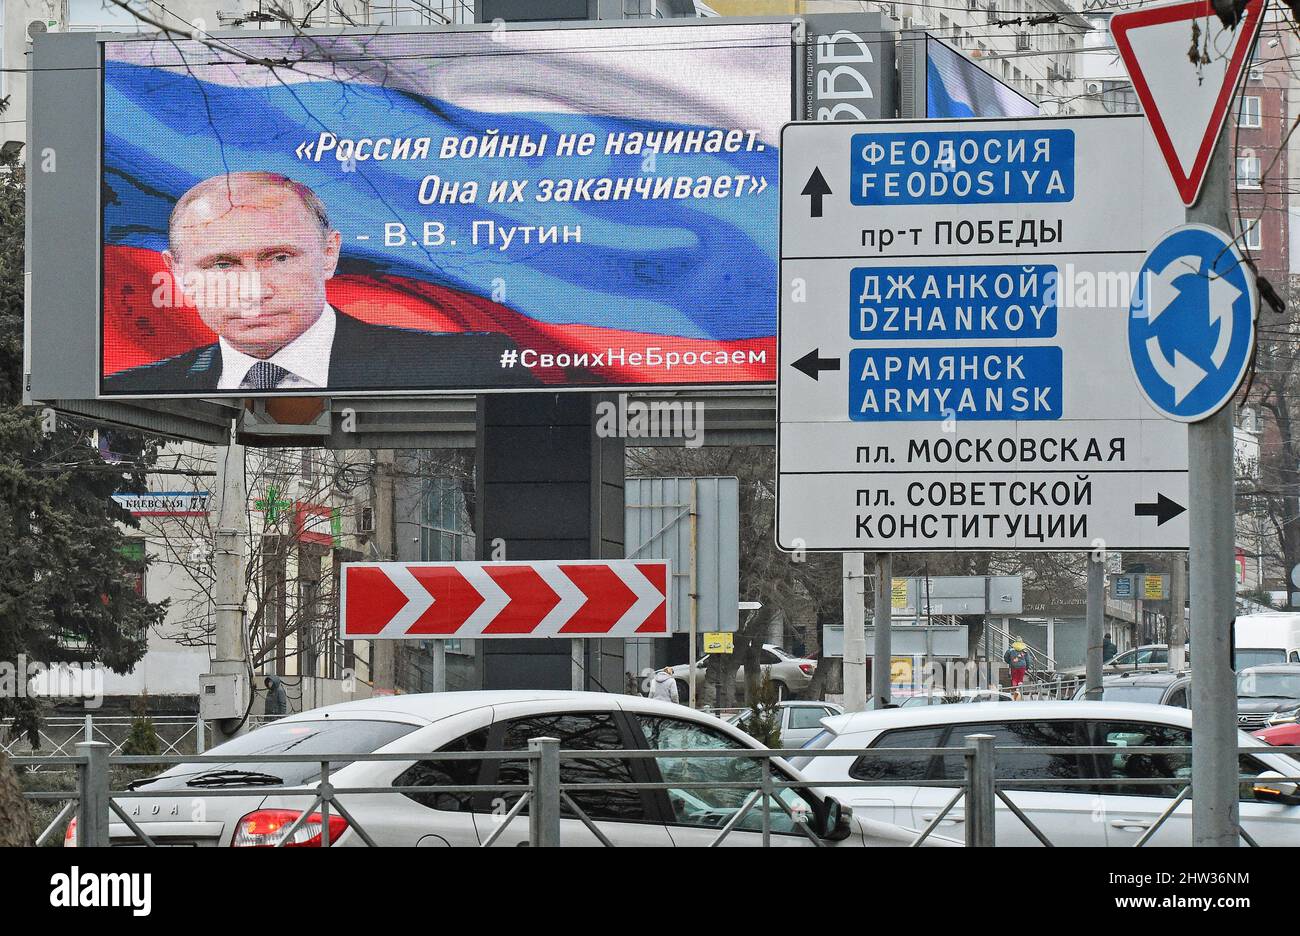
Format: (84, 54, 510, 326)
(163, 183, 339, 358)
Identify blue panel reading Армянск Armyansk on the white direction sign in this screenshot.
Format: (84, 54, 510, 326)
(849, 347, 1061, 423)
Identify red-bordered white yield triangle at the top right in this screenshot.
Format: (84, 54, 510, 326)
(1110, 0, 1266, 205)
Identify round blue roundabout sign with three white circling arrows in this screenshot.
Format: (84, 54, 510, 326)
(1128, 224, 1258, 421)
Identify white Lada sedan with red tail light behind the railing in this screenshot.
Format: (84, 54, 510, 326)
(83, 692, 953, 846)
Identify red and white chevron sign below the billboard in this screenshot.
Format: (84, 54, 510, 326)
(339, 559, 671, 640)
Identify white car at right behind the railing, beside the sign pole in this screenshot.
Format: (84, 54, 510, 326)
(792, 702, 1300, 846)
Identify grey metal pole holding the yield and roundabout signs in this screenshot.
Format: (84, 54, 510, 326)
(1187, 134, 1239, 848)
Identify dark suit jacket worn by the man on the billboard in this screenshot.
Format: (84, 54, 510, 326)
(103, 309, 540, 395)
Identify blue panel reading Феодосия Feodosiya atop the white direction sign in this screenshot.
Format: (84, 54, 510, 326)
(849, 129, 1074, 205)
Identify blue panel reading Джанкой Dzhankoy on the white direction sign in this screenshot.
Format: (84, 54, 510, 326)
(849, 264, 1057, 341)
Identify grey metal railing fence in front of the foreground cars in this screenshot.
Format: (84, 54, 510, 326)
(10, 735, 1300, 848)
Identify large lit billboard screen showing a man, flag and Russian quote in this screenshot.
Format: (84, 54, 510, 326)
(100, 23, 792, 397)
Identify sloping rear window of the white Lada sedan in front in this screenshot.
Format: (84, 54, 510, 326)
(135, 719, 416, 792)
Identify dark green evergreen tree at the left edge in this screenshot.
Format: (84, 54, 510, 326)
(0, 135, 165, 736)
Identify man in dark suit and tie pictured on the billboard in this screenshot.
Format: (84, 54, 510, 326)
(104, 172, 534, 397)
